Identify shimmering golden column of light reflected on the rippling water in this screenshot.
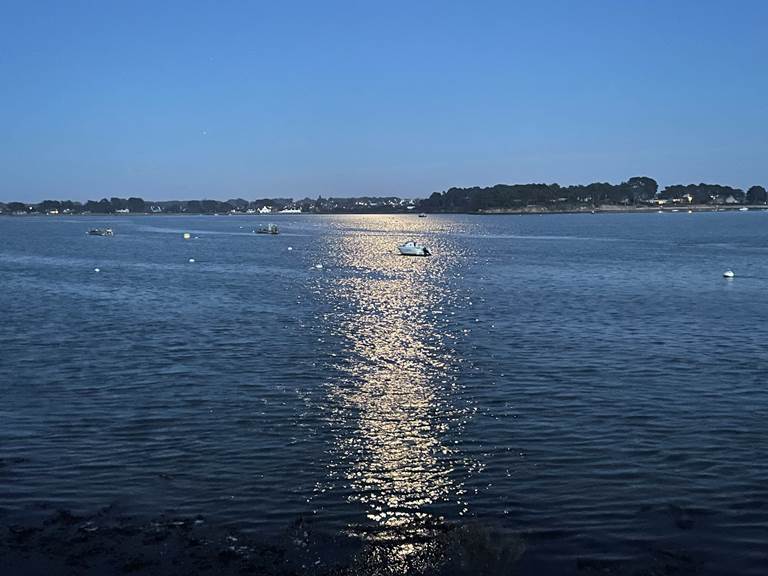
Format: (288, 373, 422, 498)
(314, 217, 474, 567)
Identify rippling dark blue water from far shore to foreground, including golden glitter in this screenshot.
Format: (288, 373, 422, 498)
(0, 212, 768, 575)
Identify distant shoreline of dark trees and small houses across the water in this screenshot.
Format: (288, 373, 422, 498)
(0, 176, 768, 214)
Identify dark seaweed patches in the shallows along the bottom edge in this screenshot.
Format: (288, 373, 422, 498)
(0, 507, 697, 576)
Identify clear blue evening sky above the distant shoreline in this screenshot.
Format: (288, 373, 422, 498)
(0, 0, 768, 201)
